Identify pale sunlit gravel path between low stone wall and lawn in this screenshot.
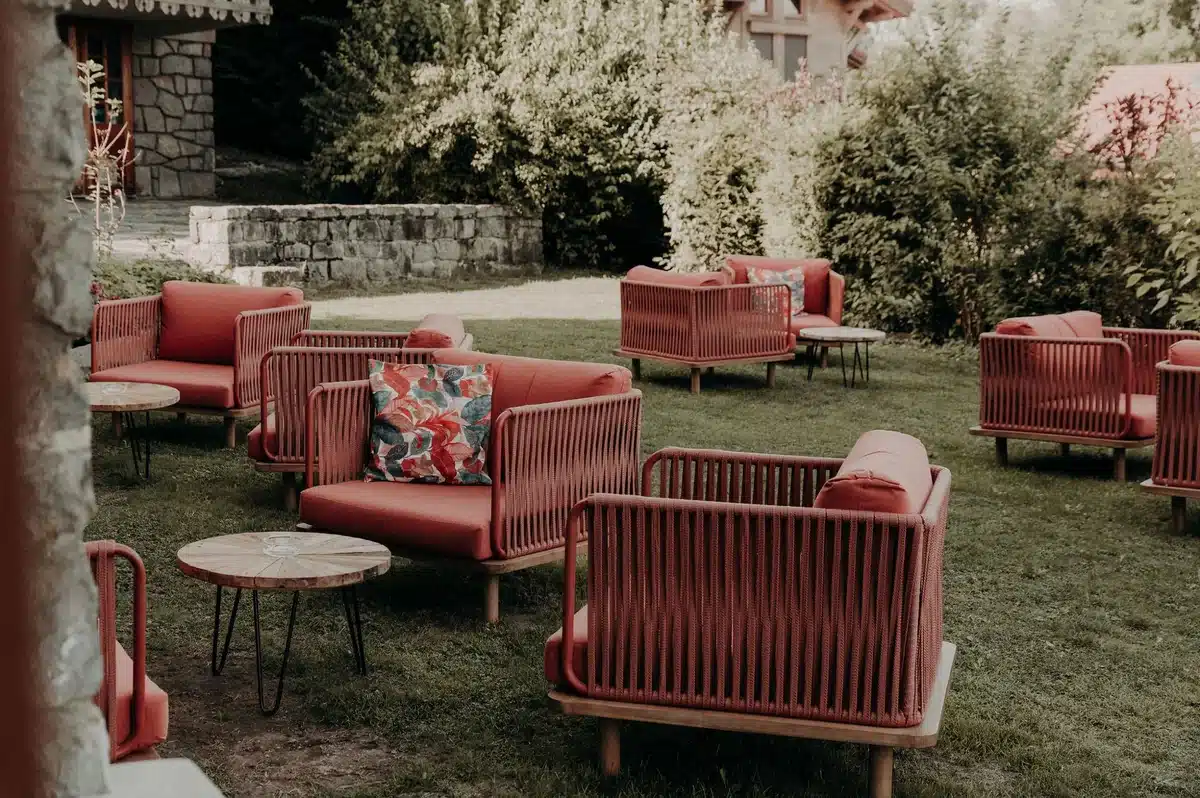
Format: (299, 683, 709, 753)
(312, 277, 620, 320)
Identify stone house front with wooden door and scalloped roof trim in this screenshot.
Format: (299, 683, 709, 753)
(58, 0, 271, 199)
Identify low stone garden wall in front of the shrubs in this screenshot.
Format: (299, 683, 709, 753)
(185, 205, 544, 286)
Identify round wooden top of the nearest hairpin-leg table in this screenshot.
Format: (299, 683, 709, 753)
(176, 532, 391, 590)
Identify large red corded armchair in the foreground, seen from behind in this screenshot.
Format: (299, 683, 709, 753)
(545, 431, 955, 798)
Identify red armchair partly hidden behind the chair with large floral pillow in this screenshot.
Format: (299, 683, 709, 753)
(246, 313, 473, 510)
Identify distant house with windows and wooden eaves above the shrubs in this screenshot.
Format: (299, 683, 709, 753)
(725, 0, 913, 80)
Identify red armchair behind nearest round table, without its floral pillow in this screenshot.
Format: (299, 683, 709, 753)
(300, 349, 642, 623)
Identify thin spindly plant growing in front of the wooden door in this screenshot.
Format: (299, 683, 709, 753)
(70, 61, 134, 257)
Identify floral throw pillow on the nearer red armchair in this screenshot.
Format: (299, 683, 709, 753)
(366, 360, 492, 485)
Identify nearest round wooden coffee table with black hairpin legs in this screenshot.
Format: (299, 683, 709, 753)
(176, 532, 391, 715)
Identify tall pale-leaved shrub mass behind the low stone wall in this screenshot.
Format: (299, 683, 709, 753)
(325, 0, 844, 269)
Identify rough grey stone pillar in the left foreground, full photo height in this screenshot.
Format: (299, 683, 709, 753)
(13, 0, 108, 796)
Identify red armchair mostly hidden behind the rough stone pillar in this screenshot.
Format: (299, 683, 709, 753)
(85, 540, 168, 762)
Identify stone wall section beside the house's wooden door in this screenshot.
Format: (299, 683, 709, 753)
(133, 29, 217, 199)
